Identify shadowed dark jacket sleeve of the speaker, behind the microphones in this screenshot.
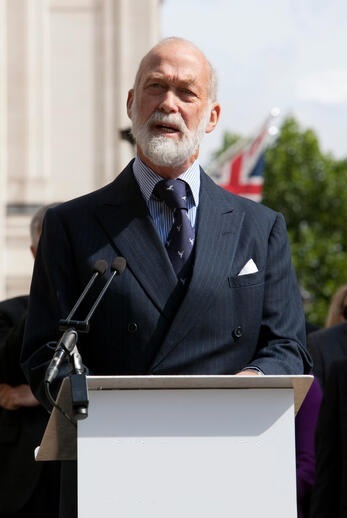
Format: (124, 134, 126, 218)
(21, 210, 75, 408)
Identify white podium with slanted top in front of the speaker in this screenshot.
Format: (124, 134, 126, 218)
(37, 376, 312, 518)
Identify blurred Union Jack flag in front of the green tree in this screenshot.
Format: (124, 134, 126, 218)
(211, 118, 273, 202)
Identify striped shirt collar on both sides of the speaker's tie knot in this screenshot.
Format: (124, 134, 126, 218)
(133, 156, 200, 207)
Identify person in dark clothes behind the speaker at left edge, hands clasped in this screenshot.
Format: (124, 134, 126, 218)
(0, 203, 59, 518)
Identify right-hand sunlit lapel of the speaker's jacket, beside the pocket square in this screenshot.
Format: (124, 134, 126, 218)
(152, 172, 244, 368)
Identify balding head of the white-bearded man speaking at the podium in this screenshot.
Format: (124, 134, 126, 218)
(127, 37, 220, 178)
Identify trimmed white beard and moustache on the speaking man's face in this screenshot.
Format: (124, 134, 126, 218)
(131, 100, 210, 167)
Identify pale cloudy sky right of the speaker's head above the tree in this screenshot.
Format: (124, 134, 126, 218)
(161, 0, 347, 165)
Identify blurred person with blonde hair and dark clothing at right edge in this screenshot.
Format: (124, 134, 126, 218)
(308, 284, 347, 518)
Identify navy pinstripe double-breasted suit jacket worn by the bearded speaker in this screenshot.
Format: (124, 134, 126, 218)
(22, 164, 310, 406)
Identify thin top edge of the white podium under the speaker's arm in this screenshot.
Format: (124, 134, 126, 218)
(87, 375, 313, 391)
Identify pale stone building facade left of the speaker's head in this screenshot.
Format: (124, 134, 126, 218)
(0, 0, 161, 299)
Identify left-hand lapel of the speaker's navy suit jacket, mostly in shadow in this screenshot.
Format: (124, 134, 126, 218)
(96, 166, 177, 317)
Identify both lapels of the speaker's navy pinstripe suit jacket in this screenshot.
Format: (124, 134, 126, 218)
(96, 165, 244, 369)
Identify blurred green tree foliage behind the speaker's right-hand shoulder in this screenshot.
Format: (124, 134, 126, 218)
(215, 117, 347, 326)
